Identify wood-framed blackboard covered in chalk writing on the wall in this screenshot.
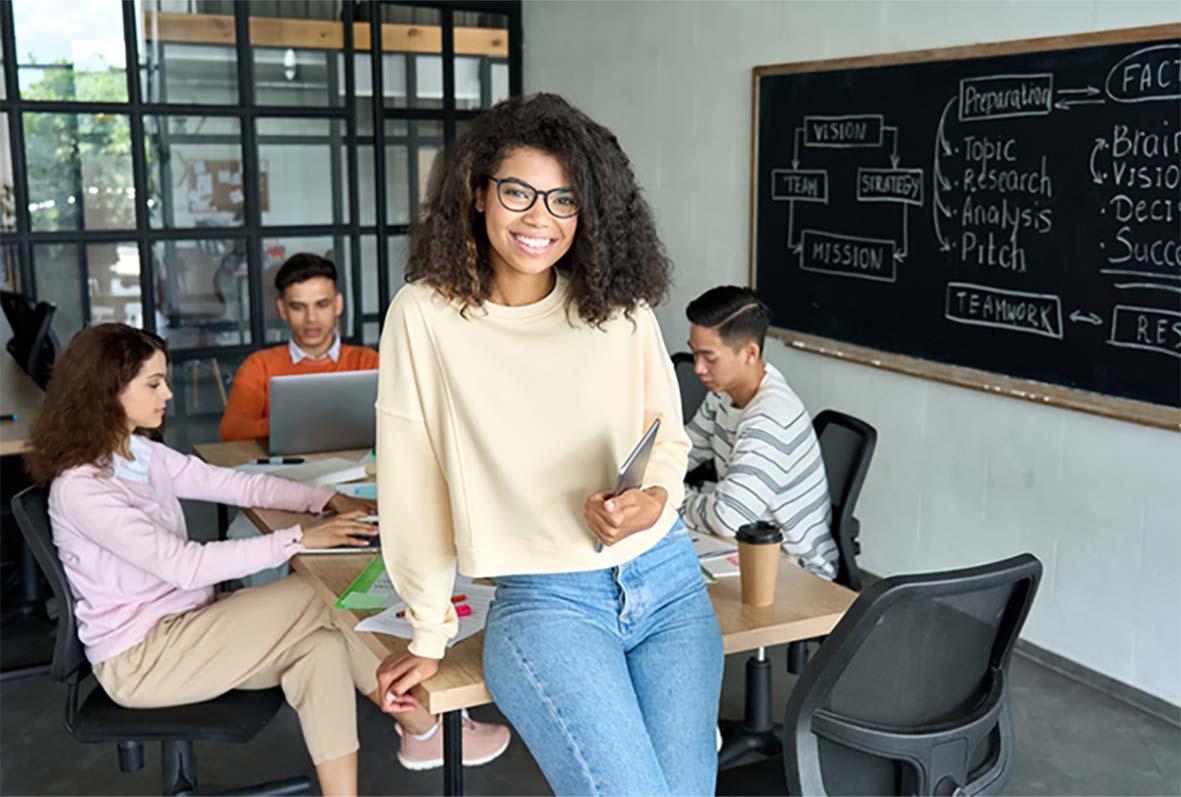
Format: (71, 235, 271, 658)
(751, 25, 1181, 427)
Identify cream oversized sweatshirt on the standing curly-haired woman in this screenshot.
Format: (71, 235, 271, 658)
(377, 275, 690, 659)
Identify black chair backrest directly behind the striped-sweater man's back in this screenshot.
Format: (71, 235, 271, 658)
(813, 410, 877, 590)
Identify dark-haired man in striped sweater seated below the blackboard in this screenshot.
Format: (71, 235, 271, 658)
(680, 286, 837, 579)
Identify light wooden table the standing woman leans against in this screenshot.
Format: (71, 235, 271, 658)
(194, 440, 856, 795)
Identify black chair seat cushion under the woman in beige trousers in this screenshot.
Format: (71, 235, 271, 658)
(74, 685, 283, 743)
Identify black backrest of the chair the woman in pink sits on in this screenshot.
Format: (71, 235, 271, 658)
(12, 485, 86, 681)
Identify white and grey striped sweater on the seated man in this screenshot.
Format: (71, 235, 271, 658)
(680, 365, 837, 579)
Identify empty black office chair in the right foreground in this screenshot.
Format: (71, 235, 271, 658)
(717, 554, 1042, 795)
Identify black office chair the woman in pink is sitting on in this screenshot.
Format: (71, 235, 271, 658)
(12, 486, 311, 795)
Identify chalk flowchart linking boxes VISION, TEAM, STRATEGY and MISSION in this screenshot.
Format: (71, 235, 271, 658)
(771, 113, 924, 282)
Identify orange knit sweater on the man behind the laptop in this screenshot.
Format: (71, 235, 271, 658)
(221, 344, 378, 440)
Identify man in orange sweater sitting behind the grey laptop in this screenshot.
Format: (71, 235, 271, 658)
(221, 253, 378, 440)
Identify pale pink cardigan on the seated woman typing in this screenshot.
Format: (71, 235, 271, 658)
(50, 438, 333, 664)
